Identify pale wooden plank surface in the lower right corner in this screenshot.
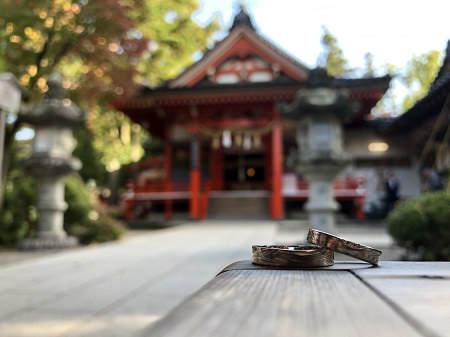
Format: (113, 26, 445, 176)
(353, 261, 450, 336)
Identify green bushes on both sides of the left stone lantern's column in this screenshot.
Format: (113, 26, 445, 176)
(0, 169, 125, 246)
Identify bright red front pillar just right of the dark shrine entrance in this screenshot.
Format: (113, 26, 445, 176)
(271, 122, 284, 219)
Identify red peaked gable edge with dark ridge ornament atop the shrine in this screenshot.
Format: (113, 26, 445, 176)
(168, 8, 309, 88)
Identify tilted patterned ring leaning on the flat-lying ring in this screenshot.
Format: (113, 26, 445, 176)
(306, 229, 381, 266)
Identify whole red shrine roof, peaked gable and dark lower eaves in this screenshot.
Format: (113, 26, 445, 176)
(113, 7, 391, 134)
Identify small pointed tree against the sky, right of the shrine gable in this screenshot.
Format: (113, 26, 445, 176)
(318, 26, 352, 77)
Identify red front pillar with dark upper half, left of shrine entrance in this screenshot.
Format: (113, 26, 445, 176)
(189, 131, 201, 219)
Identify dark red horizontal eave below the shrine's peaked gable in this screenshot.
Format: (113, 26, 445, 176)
(113, 77, 390, 137)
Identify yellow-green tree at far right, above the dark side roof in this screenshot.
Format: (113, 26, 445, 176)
(402, 50, 442, 111)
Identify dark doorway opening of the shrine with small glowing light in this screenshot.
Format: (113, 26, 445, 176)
(224, 152, 266, 191)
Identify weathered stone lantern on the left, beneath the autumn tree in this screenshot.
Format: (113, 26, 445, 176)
(21, 75, 85, 249)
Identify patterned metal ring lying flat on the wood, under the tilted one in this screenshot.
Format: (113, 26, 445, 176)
(252, 245, 334, 268)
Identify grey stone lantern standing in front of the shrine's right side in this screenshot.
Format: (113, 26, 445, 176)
(282, 68, 355, 232)
